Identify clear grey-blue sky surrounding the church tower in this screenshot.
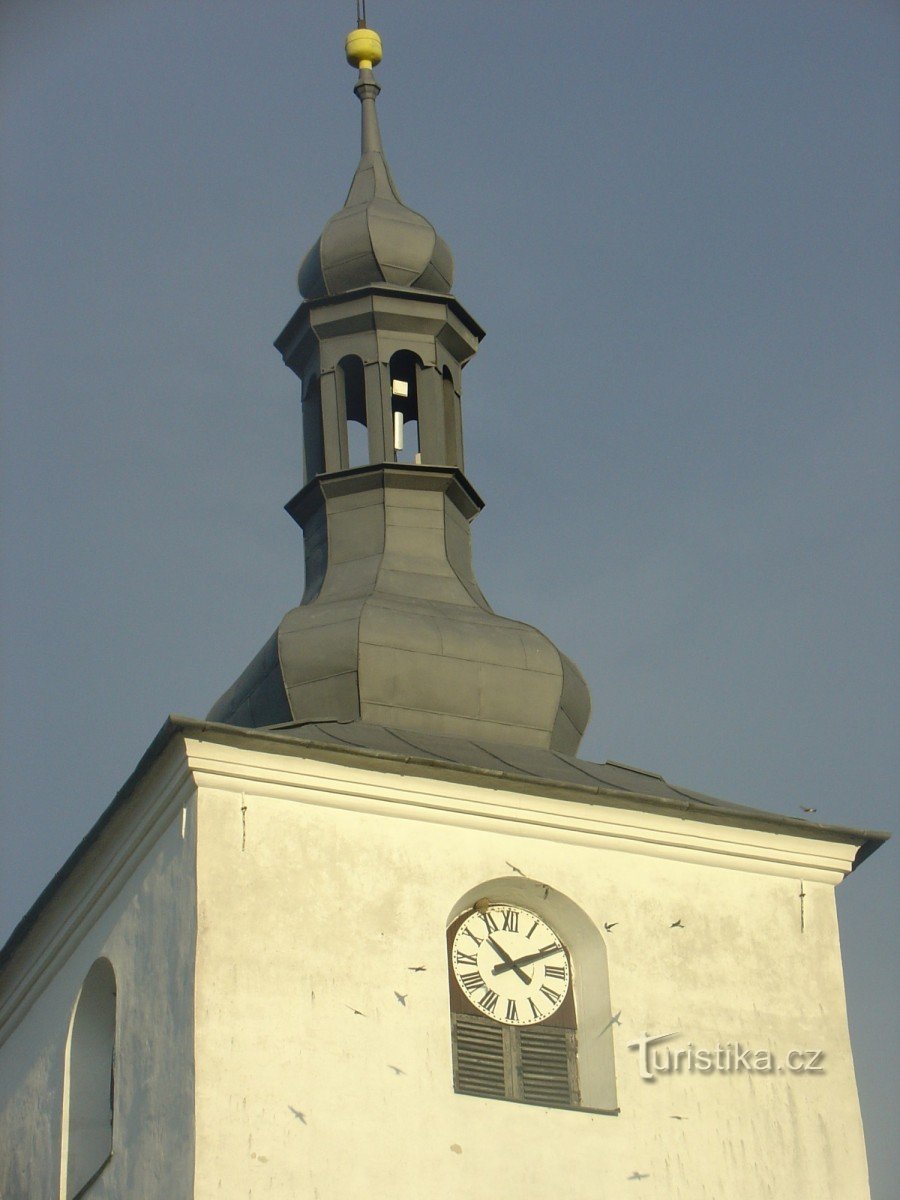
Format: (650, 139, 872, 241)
(0, 0, 900, 1198)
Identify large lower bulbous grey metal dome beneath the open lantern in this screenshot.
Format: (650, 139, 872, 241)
(209, 463, 590, 752)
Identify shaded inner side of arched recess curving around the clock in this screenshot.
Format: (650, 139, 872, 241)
(448, 876, 618, 1114)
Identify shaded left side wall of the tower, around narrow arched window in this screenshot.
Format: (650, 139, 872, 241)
(0, 748, 196, 1200)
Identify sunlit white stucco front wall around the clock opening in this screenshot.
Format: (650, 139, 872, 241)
(188, 743, 868, 1200)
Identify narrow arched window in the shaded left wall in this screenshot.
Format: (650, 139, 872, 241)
(62, 959, 115, 1200)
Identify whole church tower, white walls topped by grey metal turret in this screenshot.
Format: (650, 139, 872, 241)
(0, 18, 883, 1200)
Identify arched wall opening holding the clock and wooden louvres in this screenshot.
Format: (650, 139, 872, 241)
(448, 877, 618, 1112)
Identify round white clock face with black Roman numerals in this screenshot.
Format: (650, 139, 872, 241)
(450, 904, 569, 1025)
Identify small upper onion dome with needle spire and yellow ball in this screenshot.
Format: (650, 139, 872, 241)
(298, 28, 454, 300)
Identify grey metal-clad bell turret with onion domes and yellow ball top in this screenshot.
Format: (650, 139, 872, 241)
(209, 28, 590, 754)
